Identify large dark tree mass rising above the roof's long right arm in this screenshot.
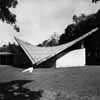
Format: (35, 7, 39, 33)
(59, 10, 100, 44)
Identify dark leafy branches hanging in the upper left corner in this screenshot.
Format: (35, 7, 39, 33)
(0, 0, 20, 32)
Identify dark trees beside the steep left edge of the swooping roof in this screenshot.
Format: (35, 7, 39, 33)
(0, 42, 32, 68)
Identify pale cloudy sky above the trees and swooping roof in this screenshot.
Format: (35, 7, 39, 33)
(0, 0, 100, 45)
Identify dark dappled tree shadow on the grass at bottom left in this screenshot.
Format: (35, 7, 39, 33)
(0, 80, 42, 100)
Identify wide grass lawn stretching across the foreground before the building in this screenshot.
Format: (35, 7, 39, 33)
(0, 65, 100, 100)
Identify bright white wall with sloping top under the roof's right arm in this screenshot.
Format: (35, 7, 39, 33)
(56, 49, 86, 68)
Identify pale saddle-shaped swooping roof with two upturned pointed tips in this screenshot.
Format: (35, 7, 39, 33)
(15, 28, 98, 65)
